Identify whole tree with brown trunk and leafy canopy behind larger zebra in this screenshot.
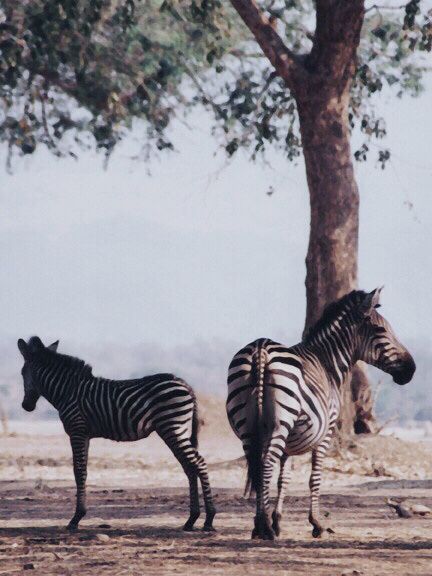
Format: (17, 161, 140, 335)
(0, 0, 432, 431)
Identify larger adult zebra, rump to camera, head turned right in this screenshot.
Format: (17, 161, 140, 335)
(226, 288, 416, 540)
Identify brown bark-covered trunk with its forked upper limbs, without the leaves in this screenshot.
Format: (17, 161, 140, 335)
(231, 0, 373, 432)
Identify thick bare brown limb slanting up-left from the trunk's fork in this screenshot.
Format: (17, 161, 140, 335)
(231, 0, 299, 88)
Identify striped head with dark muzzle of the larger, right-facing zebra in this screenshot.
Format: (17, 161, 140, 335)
(359, 288, 416, 385)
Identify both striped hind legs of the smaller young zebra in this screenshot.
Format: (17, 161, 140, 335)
(161, 430, 216, 532)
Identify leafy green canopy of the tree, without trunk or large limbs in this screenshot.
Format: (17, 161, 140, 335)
(0, 0, 432, 170)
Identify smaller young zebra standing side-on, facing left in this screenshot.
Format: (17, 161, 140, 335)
(18, 336, 216, 531)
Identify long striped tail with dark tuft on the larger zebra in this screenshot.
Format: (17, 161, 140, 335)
(245, 346, 267, 496)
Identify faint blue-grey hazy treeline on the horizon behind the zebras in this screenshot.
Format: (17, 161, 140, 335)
(0, 339, 432, 422)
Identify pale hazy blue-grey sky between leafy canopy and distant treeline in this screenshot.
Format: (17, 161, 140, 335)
(0, 82, 432, 362)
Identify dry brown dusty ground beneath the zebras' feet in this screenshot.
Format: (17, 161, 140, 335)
(0, 399, 432, 576)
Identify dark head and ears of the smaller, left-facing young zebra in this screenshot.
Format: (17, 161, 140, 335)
(18, 336, 58, 412)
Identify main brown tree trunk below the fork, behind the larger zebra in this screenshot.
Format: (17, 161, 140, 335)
(297, 85, 374, 433)
